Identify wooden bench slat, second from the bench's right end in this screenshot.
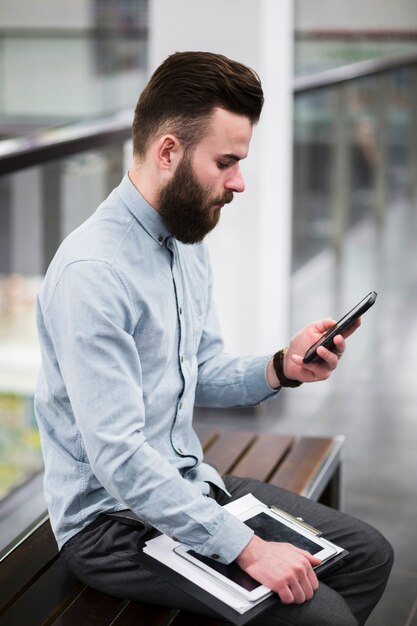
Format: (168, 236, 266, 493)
(228, 433, 294, 482)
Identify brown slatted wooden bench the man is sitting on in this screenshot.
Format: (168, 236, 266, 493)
(0, 429, 344, 626)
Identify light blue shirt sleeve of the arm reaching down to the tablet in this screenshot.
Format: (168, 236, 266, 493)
(42, 261, 253, 563)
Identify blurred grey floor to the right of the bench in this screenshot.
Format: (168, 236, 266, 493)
(196, 195, 417, 626)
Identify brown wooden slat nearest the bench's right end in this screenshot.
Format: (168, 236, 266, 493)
(269, 437, 333, 494)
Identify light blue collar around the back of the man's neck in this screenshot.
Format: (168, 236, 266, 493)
(118, 173, 170, 245)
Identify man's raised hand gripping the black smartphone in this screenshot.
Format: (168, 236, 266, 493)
(267, 318, 361, 387)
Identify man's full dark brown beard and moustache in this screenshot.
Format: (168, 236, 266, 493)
(158, 155, 233, 243)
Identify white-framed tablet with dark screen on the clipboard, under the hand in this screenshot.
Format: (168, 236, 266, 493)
(175, 504, 340, 601)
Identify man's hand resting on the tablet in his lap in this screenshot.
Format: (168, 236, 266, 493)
(237, 535, 321, 604)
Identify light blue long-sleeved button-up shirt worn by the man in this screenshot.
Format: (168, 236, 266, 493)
(35, 175, 276, 563)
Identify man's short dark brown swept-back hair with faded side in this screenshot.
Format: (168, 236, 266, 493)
(132, 52, 264, 156)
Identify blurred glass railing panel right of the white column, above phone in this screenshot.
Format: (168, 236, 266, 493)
(291, 66, 417, 331)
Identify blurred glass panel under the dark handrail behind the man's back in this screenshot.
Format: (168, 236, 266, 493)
(0, 139, 127, 499)
